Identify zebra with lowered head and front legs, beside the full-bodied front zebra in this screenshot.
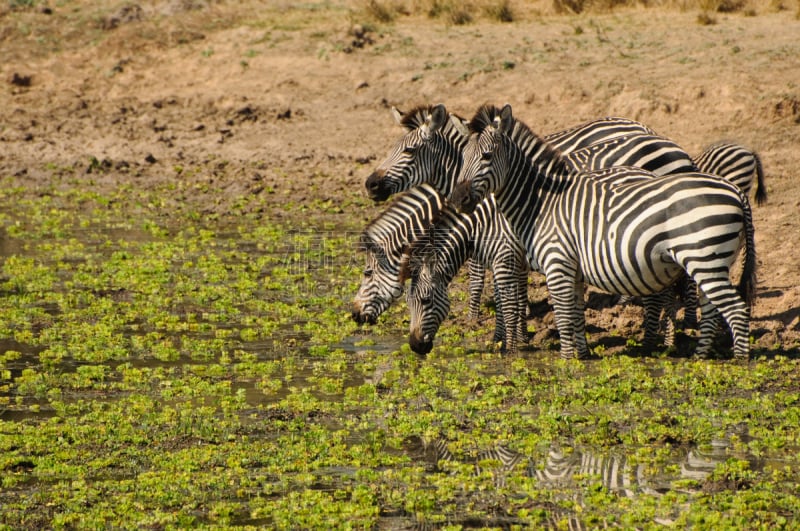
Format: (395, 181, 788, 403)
(400, 196, 529, 354)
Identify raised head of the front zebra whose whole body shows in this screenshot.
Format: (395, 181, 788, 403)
(451, 104, 514, 214)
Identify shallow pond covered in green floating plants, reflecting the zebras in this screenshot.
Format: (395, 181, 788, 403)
(0, 185, 800, 529)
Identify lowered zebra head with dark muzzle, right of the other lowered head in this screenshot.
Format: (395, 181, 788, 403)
(400, 239, 450, 355)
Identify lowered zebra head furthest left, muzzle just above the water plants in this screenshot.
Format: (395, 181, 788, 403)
(352, 236, 403, 324)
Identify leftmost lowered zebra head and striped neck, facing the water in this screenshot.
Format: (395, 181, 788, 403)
(352, 185, 444, 324)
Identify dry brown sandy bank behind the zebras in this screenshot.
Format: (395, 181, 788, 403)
(0, 1, 800, 352)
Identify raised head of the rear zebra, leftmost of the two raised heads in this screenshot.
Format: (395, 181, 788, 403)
(364, 104, 466, 201)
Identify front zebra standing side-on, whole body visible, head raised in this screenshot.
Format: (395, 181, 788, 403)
(451, 105, 756, 358)
